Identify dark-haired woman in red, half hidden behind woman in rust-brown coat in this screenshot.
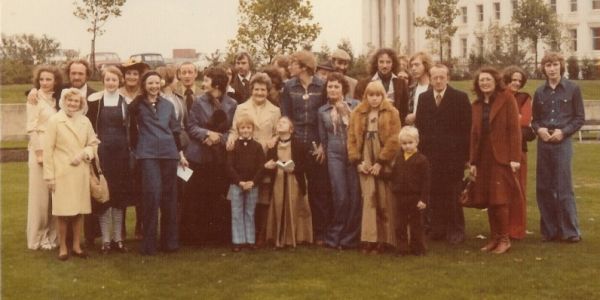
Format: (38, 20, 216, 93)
(503, 66, 535, 240)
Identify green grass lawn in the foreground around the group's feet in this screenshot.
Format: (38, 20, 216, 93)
(1, 143, 600, 299)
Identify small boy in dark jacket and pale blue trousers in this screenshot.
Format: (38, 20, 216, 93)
(227, 116, 265, 252)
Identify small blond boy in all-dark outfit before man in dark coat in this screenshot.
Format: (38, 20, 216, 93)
(391, 126, 430, 256)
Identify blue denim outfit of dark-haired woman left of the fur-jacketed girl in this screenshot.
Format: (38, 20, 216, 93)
(319, 99, 362, 248)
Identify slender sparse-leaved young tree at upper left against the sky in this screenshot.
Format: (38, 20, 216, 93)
(73, 0, 126, 71)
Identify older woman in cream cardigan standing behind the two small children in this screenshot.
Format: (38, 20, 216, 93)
(227, 73, 281, 245)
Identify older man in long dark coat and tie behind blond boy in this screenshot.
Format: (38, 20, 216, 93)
(415, 64, 471, 244)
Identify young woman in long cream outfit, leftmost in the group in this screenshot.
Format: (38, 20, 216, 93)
(27, 65, 62, 250)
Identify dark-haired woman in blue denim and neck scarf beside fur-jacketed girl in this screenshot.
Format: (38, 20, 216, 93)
(318, 73, 361, 250)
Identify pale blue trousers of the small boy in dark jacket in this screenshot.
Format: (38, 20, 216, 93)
(227, 184, 258, 245)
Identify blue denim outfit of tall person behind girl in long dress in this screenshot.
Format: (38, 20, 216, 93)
(281, 76, 331, 242)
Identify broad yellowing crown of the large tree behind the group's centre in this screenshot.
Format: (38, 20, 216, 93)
(229, 0, 321, 63)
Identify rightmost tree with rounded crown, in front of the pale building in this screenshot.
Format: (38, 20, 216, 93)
(512, 0, 560, 66)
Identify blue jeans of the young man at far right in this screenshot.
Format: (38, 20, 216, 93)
(536, 138, 581, 240)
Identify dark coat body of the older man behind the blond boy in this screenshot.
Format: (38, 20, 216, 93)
(415, 86, 471, 178)
